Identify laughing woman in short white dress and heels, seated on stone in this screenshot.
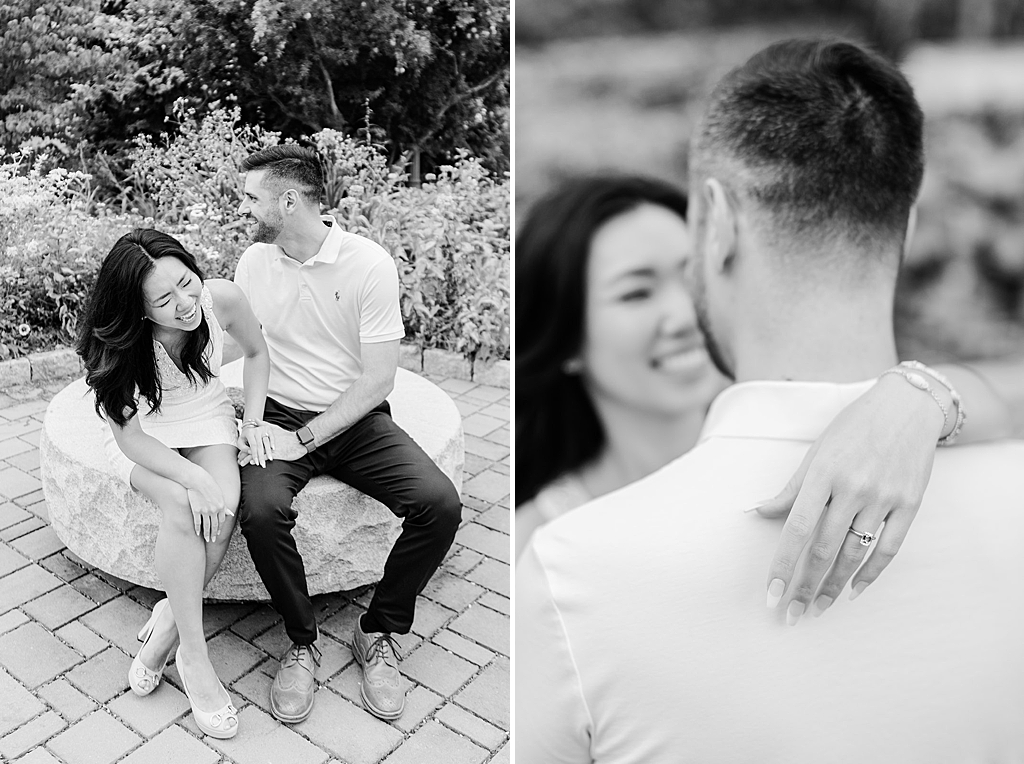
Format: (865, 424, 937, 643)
(78, 229, 270, 738)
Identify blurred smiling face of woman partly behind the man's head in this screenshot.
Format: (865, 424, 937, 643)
(579, 204, 720, 416)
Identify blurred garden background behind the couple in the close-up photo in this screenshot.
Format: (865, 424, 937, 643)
(515, 0, 1024, 360)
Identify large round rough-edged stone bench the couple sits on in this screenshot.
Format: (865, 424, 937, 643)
(39, 362, 465, 600)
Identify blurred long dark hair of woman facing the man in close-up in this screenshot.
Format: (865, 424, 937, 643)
(515, 175, 686, 505)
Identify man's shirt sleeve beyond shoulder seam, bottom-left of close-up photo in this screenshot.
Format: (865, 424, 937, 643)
(515, 544, 594, 764)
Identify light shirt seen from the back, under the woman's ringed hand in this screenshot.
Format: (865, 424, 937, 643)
(514, 382, 1024, 764)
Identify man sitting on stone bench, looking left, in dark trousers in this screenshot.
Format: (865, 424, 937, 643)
(234, 145, 462, 723)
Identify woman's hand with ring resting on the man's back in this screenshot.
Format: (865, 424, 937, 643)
(757, 374, 944, 625)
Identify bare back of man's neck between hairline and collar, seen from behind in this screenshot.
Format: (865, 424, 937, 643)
(734, 292, 898, 382)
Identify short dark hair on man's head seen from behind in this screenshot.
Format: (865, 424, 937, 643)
(692, 40, 925, 248)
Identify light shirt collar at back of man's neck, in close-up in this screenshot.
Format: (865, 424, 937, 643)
(698, 379, 876, 442)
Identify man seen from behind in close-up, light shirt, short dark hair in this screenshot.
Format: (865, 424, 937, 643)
(514, 41, 1024, 764)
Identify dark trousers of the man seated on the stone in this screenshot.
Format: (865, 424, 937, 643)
(239, 397, 462, 644)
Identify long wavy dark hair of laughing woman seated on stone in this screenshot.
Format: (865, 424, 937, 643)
(76, 228, 213, 427)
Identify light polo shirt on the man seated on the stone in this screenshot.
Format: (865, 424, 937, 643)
(234, 216, 406, 412)
